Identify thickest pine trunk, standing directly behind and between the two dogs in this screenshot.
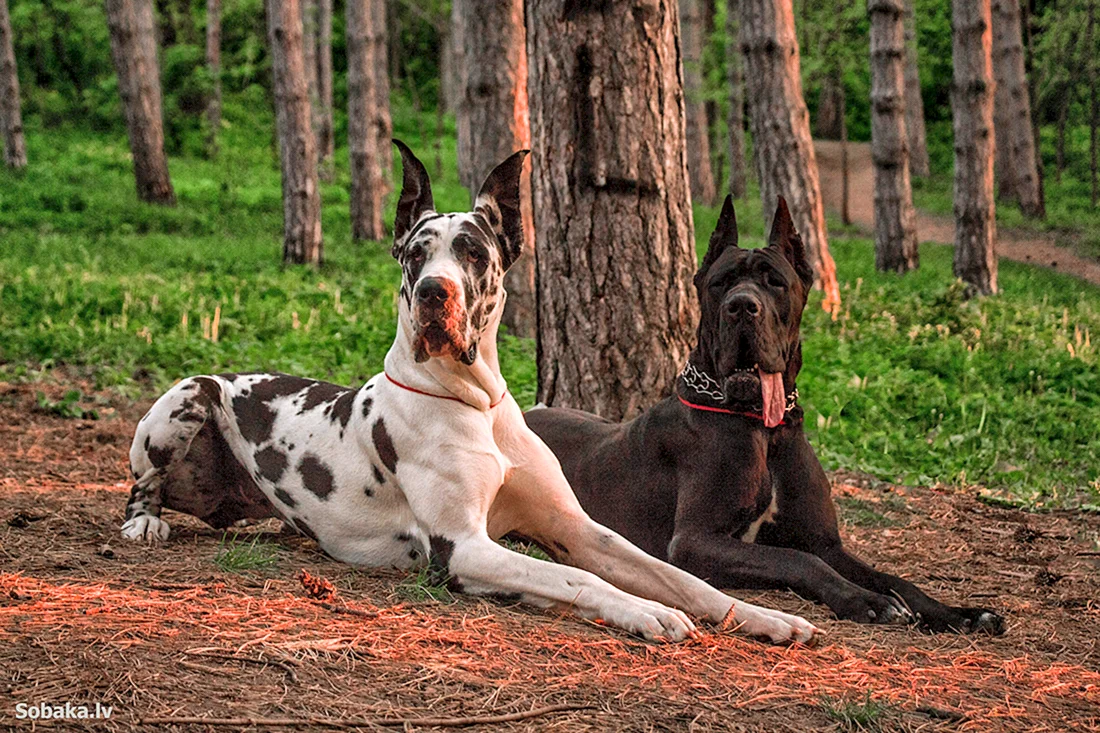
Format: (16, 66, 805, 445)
(527, 0, 697, 420)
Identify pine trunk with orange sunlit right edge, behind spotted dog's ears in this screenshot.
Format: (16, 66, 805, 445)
(451, 0, 535, 336)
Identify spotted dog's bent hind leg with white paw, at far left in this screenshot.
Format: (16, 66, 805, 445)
(121, 376, 220, 541)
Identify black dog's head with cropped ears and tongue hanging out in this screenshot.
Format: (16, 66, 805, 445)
(695, 196, 813, 427)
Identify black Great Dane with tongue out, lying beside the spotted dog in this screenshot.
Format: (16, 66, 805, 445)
(527, 198, 1004, 633)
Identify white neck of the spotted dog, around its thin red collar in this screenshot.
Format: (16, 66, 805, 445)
(385, 300, 508, 411)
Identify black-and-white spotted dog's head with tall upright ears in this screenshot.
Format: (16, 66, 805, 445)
(393, 140, 528, 364)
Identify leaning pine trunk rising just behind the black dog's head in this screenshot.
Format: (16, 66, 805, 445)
(741, 0, 840, 313)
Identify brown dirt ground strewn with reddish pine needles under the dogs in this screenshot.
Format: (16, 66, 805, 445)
(0, 383, 1100, 731)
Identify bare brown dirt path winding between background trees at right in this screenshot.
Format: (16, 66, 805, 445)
(814, 140, 1100, 285)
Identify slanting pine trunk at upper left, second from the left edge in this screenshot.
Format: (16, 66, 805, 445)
(106, 0, 176, 205)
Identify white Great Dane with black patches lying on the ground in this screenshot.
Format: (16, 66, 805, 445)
(122, 141, 816, 642)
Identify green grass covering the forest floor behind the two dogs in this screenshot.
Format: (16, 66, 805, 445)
(0, 98, 1100, 507)
